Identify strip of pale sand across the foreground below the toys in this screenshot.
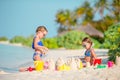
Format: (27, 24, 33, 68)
(0, 67, 120, 80)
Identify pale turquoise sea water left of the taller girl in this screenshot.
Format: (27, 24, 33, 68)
(0, 44, 34, 72)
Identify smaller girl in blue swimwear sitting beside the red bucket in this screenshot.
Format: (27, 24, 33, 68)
(82, 37, 96, 65)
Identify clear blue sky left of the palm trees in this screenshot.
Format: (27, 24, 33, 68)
(0, 0, 84, 39)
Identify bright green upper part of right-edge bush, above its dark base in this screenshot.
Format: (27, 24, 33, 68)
(103, 24, 120, 49)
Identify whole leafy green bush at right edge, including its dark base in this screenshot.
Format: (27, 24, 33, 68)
(103, 23, 120, 61)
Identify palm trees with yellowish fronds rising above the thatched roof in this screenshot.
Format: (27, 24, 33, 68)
(56, 0, 120, 33)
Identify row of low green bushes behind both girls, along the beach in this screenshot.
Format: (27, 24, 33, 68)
(7, 31, 100, 49)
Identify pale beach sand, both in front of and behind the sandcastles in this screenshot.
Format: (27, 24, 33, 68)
(0, 49, 120, 80)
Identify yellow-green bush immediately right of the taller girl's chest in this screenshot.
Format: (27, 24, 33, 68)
(42, 37, 58, 49)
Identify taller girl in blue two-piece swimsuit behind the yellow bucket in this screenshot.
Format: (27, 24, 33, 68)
(32, 26, 48, 61)
